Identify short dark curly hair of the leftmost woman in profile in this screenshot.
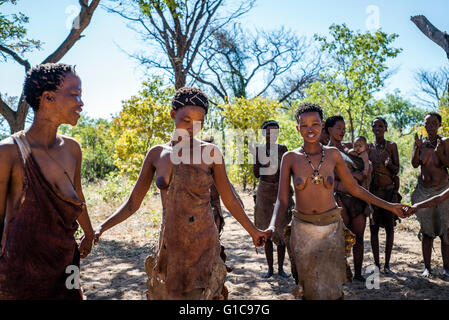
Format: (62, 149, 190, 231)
(23, 63, 77, 111)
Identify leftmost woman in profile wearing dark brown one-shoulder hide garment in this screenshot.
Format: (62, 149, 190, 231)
(0, 63, 94, 300)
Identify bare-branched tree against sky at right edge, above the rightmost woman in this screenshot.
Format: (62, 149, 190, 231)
(415, 67, 449, 109)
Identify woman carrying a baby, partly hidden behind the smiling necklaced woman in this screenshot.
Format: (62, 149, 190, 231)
(325, 116, 368, 282)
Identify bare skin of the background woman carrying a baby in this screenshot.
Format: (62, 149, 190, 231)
(328, 121, 368, 281)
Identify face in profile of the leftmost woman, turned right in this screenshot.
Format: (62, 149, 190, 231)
(40, 73, 84, 126)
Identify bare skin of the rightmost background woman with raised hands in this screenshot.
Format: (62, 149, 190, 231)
(412, 115, 449, 277)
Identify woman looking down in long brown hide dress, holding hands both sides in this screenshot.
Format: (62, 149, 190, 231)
(95, 87, 266, 300)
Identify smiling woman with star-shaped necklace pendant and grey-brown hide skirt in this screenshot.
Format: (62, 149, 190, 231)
(267, 103, 408, 299)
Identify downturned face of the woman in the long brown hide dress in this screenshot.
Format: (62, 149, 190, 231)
(170, 106, 206, 139)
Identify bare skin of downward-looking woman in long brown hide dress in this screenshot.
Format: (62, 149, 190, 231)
(95, 106, 267, 247)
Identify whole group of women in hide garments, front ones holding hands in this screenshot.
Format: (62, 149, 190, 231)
(0, 64, 449, 300)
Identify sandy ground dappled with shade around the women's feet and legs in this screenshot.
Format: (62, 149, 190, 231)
(81, 188, 449, 300)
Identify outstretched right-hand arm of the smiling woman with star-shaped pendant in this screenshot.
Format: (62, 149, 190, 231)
(332, 151, 408, 217)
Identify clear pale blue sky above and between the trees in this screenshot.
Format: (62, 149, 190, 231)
(0, 0, 449, 118)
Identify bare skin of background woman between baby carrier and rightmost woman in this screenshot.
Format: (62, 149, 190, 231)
(369, 119, 400, 273)
